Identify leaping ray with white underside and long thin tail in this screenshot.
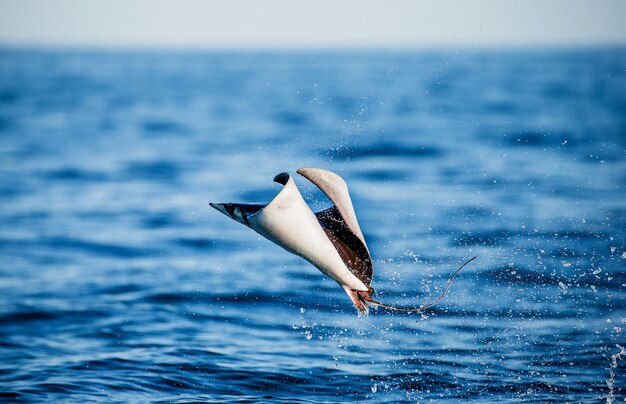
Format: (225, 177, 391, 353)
(211, 168, 476, 314)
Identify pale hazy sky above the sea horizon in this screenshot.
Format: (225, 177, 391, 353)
(0, 0, 626, 49)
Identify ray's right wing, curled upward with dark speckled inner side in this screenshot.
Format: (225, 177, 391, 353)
(298, 168, 374, 288)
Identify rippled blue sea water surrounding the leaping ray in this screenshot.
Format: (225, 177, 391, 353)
(0, 48, 626, 403)
